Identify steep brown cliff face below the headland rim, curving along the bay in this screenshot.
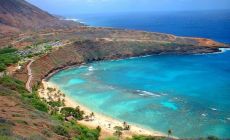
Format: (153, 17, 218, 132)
(28, 40, 221, 85)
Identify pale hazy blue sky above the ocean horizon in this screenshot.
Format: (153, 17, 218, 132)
(27, 0, 230, 15)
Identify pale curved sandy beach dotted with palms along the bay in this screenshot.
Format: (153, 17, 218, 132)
(39, 80, 166, 139)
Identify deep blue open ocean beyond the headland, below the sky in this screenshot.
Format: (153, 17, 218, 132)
(66, 10, 230, 43)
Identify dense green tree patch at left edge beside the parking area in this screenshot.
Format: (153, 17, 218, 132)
(0, 47, 20, 72)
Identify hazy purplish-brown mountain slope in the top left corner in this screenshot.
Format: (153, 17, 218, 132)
(0, 0, 82, 34)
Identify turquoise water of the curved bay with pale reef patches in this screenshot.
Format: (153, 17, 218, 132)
(49, 51, 230, 138)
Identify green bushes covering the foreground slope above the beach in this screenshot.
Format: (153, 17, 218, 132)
(0, 76, 101, 140)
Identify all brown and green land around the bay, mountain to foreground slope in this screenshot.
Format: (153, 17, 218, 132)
(0, 0, 227, 140)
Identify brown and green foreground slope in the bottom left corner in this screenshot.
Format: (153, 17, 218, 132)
(0, 76, 99, 140)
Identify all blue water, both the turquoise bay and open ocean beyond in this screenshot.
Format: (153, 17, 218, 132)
(49, 11, 230, 138)
